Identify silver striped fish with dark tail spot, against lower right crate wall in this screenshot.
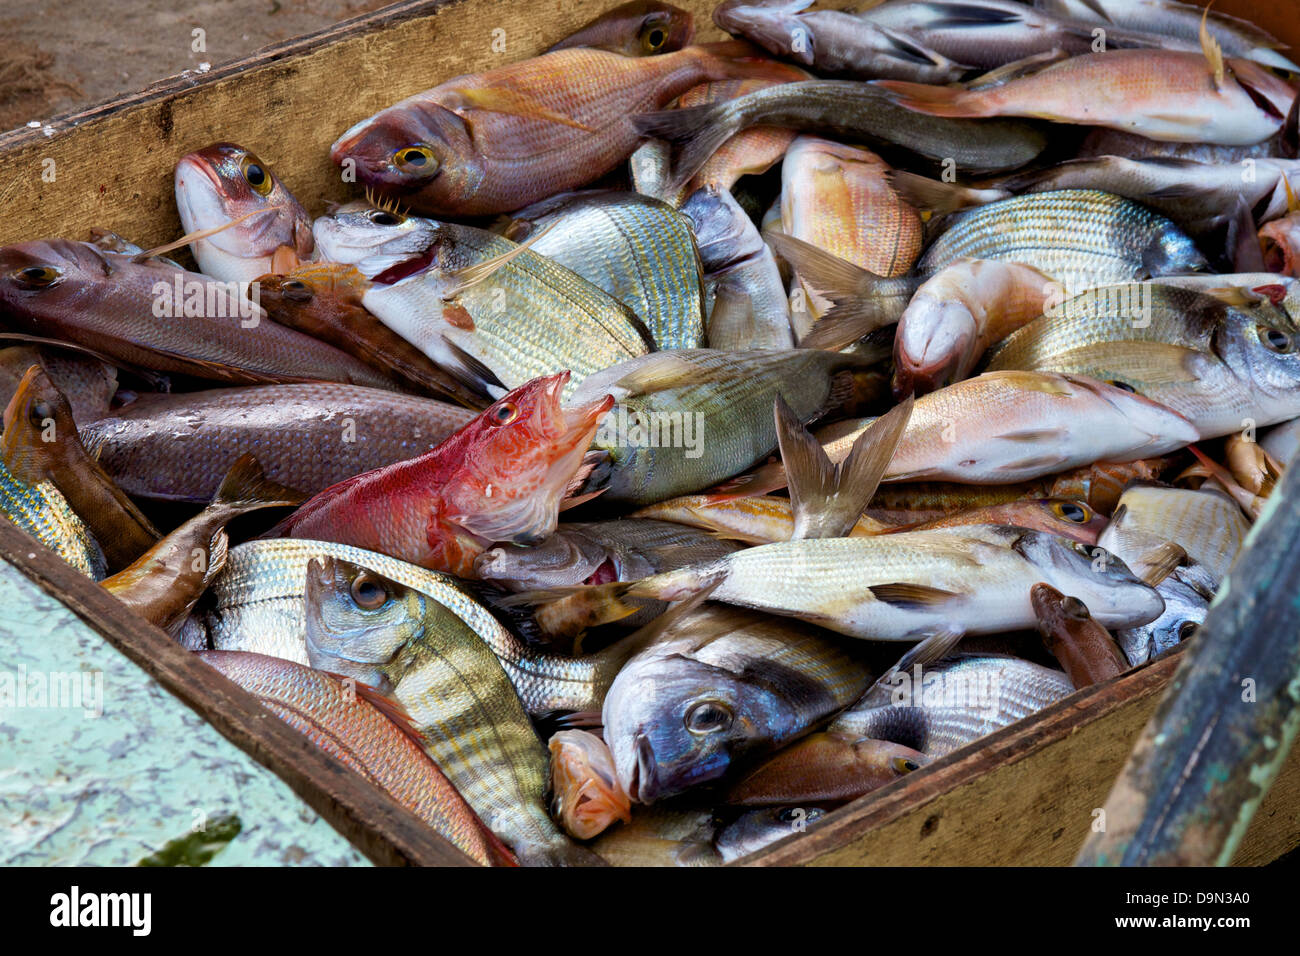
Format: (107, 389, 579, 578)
(827, 653, 1074, 757)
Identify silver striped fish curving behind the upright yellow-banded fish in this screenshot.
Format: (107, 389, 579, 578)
(203, 538, 621, 714)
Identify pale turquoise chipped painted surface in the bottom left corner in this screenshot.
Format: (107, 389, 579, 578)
(0, 561, 369, 866)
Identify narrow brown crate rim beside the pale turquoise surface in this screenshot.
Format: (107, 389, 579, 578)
(0, 516, 473, 866)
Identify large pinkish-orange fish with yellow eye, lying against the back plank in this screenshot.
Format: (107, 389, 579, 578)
(330, 43, 790, 217)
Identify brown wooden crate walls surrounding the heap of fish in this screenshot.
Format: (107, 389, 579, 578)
(0, 0, 1300, 865)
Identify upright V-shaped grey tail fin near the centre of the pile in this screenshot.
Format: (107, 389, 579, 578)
(775, 395, 915, 540)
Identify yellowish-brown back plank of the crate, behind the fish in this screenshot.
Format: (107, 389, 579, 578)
(0, 0, 743, 246)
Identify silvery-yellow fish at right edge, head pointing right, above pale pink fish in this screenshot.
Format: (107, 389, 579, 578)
(984, 284, 1300, 438)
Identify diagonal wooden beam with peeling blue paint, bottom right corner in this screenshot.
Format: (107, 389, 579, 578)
(1078, 455, 1300, 866)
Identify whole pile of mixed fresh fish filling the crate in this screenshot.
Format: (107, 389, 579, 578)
(0, 0, 1300, 865)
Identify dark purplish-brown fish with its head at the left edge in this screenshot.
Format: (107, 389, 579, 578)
(0, 239, 393, 388)
